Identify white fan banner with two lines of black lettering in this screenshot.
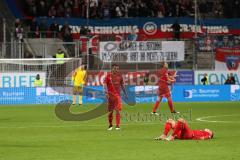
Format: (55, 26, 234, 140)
(99, 41, 185, 63)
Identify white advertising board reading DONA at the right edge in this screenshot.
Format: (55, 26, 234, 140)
(194, 71, 240, 85)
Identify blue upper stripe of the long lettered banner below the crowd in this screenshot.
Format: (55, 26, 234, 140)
(34, 17, 240, 31)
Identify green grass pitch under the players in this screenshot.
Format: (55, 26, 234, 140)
(0, 102, 240, 160)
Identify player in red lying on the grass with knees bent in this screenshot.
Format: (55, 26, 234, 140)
(155, 118, 213, 141)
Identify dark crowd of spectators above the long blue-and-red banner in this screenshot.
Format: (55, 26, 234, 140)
(23, 0, 240, 19)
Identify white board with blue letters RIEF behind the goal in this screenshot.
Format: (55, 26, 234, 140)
(0, 72, 46, 88)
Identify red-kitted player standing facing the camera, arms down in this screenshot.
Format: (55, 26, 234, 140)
(104, 64, 128, 130)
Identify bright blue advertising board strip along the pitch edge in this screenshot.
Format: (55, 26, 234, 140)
(0, 85, 236, 104)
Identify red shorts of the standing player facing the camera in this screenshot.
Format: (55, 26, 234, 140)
(108, 95, 122, 111)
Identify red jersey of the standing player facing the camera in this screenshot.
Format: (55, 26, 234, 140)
(104, 73, 123, 95)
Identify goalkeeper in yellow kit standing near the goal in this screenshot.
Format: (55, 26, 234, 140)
(72, 65, 87, 105)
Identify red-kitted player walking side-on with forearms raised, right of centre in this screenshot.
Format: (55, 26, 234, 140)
(152, 62, 179, 115)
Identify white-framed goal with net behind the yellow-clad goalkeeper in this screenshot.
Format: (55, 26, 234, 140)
(0, 58, 82, 88)
